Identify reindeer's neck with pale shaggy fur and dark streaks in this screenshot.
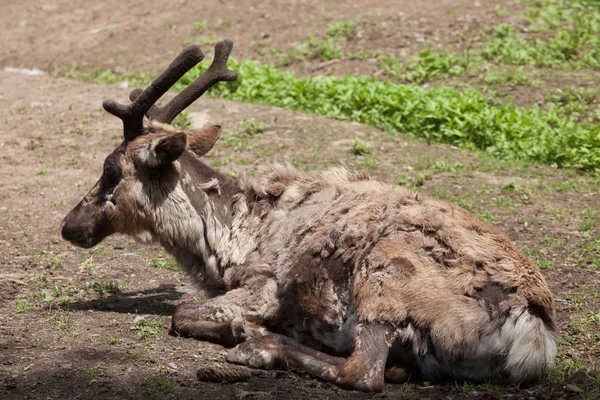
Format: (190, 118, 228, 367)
(156, 152, 255, 289)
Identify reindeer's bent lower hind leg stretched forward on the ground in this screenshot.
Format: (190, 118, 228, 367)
(227, 324, 392, 392)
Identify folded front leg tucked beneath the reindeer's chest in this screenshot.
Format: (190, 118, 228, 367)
(171, 282, 277, 347)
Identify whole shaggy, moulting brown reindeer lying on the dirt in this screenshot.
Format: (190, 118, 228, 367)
(62, 41, 557, 391)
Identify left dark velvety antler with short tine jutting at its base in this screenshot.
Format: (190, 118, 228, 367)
(102, 45, 204, 140)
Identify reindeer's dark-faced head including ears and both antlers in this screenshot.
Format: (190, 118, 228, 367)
(61, 40, 237, 248)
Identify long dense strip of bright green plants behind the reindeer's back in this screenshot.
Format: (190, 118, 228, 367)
(175, 61, 600, 173)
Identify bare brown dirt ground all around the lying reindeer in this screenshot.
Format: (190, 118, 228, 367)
(0, 0, 600, 399)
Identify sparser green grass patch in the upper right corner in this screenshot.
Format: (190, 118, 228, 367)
(366, 0, 600, 86)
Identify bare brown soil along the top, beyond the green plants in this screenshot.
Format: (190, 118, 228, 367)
(0, 0, 521, 73)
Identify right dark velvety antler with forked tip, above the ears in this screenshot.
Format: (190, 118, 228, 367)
(130, 39, 238, 124)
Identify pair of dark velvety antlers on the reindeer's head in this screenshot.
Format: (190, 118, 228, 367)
(102, 40, 237, 140)
